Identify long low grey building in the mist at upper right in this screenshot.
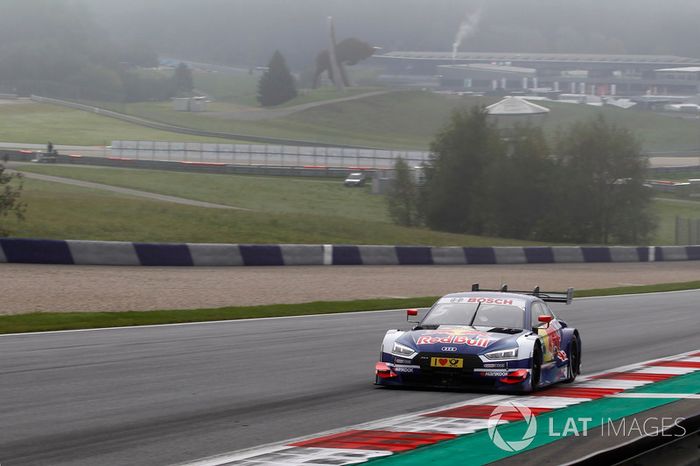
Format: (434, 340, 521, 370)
(371, 52, 700, 96)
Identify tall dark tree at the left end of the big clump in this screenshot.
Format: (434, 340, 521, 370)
(421, 107, 504, 234)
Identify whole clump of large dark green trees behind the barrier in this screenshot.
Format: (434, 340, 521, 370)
(412, 108, 654, 244)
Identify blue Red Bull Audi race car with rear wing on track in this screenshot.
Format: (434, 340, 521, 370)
(375, 284, 581, 392)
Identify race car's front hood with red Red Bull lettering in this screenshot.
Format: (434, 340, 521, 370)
(398, 326, 525, 354)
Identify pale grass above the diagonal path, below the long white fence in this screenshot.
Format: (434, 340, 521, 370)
(21, 165, 700, 245)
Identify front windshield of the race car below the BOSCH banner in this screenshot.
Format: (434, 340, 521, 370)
(420, 303, 525, 328)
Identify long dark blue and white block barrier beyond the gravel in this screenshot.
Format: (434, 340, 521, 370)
(0, 238, 700, 267)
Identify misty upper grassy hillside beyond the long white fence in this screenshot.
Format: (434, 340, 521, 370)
(0, 89, 700, 151)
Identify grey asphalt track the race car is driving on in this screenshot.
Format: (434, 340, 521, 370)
(0, 291, 700, 466)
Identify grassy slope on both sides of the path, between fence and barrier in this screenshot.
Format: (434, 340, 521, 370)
(13, 165, 700, 246)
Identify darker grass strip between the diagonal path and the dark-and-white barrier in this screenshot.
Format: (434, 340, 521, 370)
(2, 175, 535, 246)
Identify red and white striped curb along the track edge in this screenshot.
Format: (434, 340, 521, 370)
(183, 351, 700, 466)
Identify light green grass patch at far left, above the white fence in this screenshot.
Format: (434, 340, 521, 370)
(0, 103, 231, 146)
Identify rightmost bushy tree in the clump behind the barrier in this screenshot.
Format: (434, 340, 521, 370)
(550, 116, 654, 244)
